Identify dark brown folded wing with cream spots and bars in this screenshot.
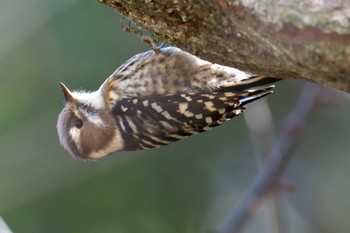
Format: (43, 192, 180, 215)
(112, 86, 273, 150)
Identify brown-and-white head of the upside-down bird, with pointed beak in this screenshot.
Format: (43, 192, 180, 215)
(57, 83, 122, 159)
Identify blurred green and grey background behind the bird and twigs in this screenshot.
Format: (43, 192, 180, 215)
(0, 0, 350, 233)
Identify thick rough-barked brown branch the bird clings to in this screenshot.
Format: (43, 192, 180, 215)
(100, 0, 350, 92)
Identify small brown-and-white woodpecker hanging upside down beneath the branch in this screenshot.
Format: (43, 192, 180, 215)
(57, 46, 279, 160)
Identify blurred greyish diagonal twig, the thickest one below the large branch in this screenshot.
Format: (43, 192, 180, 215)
(219, 83, 320, 233)
